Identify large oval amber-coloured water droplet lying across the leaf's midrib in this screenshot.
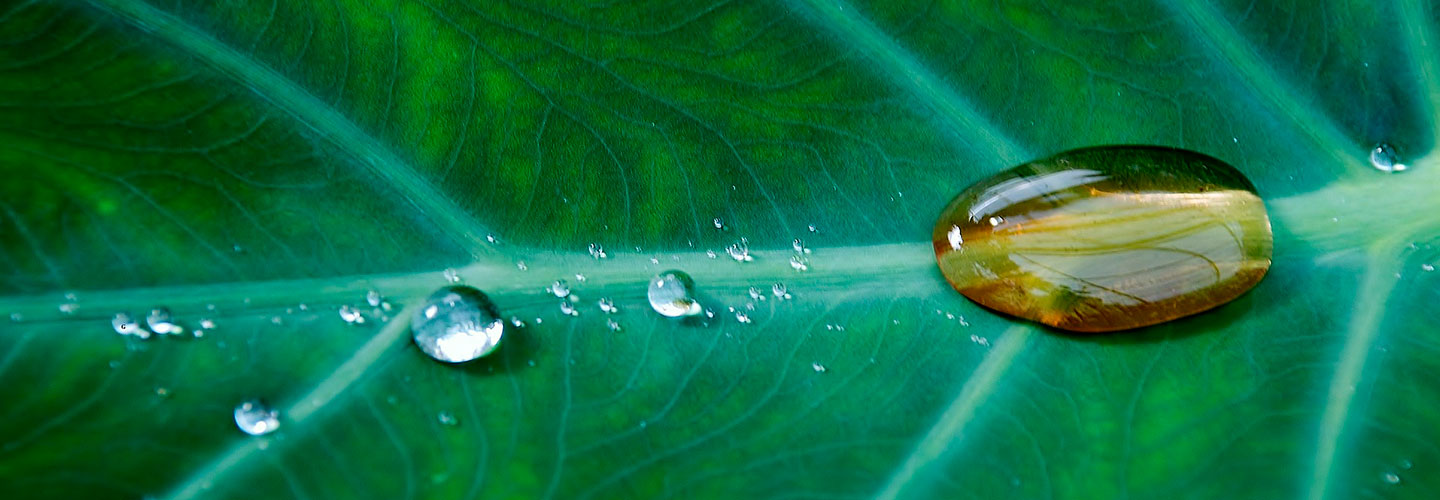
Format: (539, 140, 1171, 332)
(933, 146, 1272, 331)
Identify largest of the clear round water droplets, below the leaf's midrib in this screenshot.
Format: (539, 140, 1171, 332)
(410, 285, 505, 363)
